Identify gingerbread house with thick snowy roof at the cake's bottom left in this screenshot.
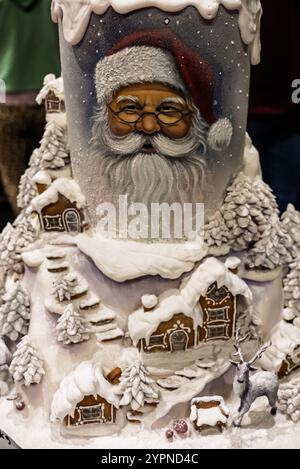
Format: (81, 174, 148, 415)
(51, 361, 119, 429)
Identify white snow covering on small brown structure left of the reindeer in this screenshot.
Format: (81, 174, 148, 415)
(190, 396, 229, 427)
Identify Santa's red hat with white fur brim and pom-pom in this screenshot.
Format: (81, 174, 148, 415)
(95, 30, 233, 151)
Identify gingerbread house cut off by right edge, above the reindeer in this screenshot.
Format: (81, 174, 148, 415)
(259, 320, 300, 378)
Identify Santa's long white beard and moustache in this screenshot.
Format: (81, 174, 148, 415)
(90, 106, 207, 206)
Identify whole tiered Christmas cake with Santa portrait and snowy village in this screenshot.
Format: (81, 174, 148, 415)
(0, 0, 300, 448)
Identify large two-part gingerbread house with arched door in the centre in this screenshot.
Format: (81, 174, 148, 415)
(128, 258, 252, 353)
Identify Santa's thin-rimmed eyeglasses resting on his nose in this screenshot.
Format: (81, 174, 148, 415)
(108, 106, 192, 125)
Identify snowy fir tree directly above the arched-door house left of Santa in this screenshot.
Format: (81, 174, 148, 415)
(40, 120, 69, 169)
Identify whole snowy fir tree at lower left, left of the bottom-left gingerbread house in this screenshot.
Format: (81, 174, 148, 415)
(9, 335, 45, 386)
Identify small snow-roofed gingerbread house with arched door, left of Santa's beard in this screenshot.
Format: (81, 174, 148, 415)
(32, 178, 85, 233)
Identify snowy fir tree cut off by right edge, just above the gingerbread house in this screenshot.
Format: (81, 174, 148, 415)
(284, 257, 300, 316)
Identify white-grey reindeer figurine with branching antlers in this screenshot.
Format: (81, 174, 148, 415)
(231, 331, 279, 427)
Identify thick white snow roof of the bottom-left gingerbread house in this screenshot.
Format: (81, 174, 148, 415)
(51, 361, 119, 422)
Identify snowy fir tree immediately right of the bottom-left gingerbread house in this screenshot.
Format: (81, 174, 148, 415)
(118, 361, 159, 411)
